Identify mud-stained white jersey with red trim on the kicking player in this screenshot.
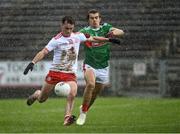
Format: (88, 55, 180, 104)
(45, 32, 86, 74)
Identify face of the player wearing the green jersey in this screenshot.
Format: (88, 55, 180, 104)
(89, 13, 101, 28)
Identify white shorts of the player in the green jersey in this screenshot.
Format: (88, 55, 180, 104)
(83, 64, 109, 84)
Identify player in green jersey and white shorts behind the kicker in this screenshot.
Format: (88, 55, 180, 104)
(76, 9, 124, 125)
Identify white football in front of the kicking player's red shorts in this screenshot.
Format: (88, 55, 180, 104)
(54, 82, 71, 96)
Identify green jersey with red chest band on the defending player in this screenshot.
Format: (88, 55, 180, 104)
(80, 23, 112, 69)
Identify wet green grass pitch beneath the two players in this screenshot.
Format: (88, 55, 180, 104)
(0, 97, 180, 133)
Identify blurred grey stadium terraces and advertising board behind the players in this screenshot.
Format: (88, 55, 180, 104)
(0, 0, 180, 98)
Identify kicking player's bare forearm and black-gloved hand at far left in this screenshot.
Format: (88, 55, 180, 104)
(24, 49, 48, 75)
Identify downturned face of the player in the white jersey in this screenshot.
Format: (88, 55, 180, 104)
(62, 22, 74, 36)
